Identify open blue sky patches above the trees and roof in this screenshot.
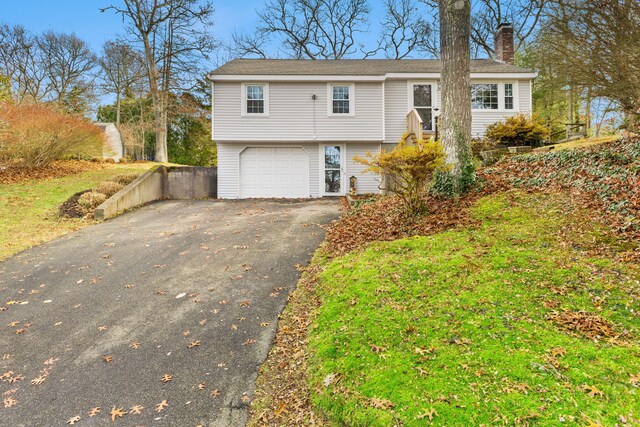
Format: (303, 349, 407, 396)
(0, 0, 382, 66)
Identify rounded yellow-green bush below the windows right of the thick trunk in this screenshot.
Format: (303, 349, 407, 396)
(485, 114, 547, 147)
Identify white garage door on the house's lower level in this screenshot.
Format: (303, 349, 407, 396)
(240, 147, 309, 198)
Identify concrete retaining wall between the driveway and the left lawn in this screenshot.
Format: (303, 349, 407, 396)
(93, 165, 218, 220)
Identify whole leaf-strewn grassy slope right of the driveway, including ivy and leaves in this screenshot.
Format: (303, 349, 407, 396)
(250, 139, 640, 427)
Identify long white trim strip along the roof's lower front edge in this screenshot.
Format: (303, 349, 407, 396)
(209, 72, 538, 82)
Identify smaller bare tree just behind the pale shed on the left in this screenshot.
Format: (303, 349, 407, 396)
(100, 40, 145, 124)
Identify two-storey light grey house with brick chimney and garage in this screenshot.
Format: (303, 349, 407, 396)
(209, 24, 536, 199)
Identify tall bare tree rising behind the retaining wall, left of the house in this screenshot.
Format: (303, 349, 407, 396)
(101, 0, 216, 162)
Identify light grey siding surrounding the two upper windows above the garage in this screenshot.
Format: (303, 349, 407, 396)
(213, 82, 383, 143)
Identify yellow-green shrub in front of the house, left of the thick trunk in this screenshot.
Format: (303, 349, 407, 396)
(354, 138, 444, 213)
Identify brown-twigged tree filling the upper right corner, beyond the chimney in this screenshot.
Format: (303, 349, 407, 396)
(541, 0, 640, 132)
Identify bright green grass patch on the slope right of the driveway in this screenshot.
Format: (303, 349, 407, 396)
(307, 192, 640, 427)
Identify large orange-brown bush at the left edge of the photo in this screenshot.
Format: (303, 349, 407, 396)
(0, 103, 104, 168)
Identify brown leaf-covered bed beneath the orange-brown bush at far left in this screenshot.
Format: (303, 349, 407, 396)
(0, 160, 104, 184)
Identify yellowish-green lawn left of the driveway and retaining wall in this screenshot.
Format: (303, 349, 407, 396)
(0, 163, 153, 259)
